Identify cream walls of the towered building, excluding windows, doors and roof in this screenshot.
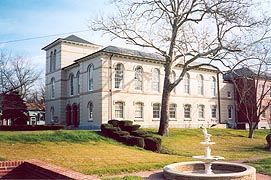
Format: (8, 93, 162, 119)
(46, 38, 235, 128)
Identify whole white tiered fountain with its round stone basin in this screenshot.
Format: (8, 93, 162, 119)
(164, 128, 256, 180)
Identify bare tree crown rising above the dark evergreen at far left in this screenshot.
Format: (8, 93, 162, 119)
(0, 51, 41, 99)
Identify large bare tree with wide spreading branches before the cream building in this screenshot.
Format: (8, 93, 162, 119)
(90, 0, 269, 135)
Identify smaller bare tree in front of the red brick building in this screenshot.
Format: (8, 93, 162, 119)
(224, 41, 271, 138)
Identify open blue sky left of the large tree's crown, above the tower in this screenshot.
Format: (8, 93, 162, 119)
(0, 0, 124, 72)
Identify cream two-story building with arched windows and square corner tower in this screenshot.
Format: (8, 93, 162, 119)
(42, 35, 235, 129)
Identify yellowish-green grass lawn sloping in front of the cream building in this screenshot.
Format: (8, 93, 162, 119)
(0, 129, 271, 178)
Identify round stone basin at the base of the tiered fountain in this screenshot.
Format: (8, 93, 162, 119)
(164, 162, 256, 180)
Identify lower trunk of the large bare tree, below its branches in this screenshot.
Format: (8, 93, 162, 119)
(158, 73, 170, 136)
